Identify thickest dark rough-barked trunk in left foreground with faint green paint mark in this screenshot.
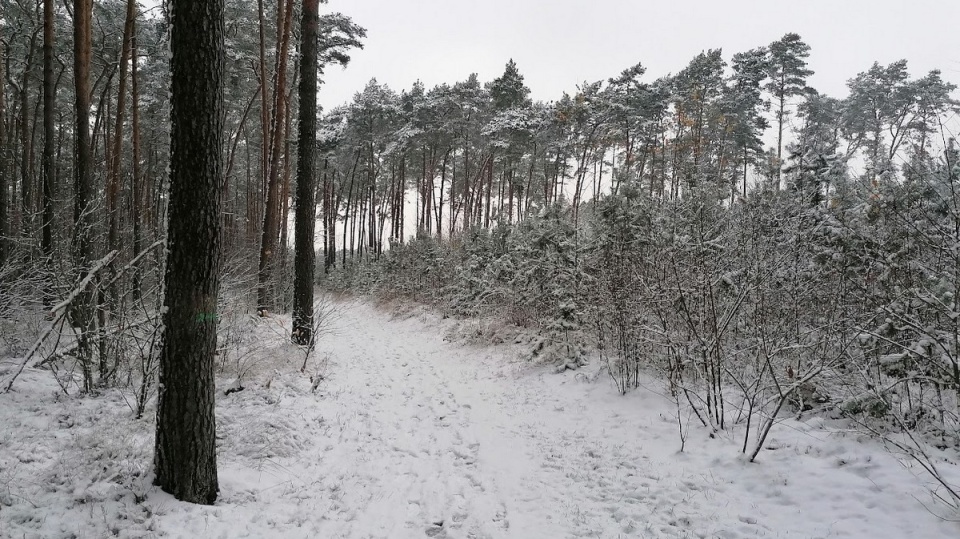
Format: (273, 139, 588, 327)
(155, 0, 224, 504)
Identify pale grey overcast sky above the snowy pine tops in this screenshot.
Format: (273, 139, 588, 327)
(320, 0, 960, 108)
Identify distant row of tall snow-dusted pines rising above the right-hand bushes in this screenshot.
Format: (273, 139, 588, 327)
(321, 34, 954, 268)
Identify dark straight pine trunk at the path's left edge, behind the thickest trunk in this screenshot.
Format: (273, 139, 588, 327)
(292, 0, 320, 345)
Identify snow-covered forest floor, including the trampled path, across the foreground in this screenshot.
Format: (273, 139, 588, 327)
(0, 302, 960, 539)
